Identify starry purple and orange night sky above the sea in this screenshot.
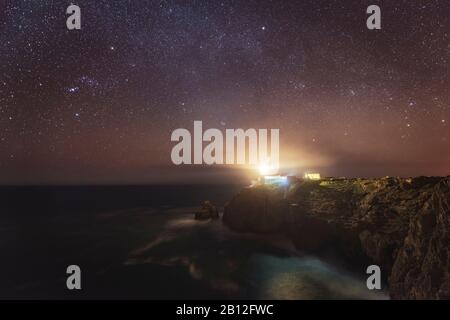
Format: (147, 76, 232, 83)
(0, 0, 450, 184)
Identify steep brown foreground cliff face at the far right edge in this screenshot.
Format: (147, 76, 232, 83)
(390, 178, 450, 299)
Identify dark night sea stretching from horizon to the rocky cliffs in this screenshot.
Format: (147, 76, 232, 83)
(0, 185, 387, 299)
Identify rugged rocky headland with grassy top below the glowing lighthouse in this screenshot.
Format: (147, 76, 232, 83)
(223, 176, 450, 299)
